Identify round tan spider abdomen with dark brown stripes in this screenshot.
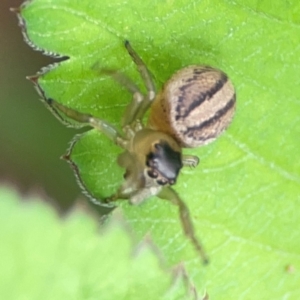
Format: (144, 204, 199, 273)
(149, 66, 235, 147)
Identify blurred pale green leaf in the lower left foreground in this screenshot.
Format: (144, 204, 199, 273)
(0, 187, 195, 300)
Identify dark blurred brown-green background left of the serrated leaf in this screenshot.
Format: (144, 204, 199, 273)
(0, 0, 81, 209)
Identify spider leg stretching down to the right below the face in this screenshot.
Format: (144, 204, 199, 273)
(158, 187, 209, 264)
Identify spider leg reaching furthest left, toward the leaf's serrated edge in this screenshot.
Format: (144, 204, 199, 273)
(47, 99, 126, 147)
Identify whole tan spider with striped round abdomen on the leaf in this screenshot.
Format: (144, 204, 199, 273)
(47, 41, 235, 263)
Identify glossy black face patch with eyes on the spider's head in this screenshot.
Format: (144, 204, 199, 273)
(146, 141, 182, 185)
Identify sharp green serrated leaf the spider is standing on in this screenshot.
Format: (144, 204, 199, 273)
(17, 0, 300, 299)
